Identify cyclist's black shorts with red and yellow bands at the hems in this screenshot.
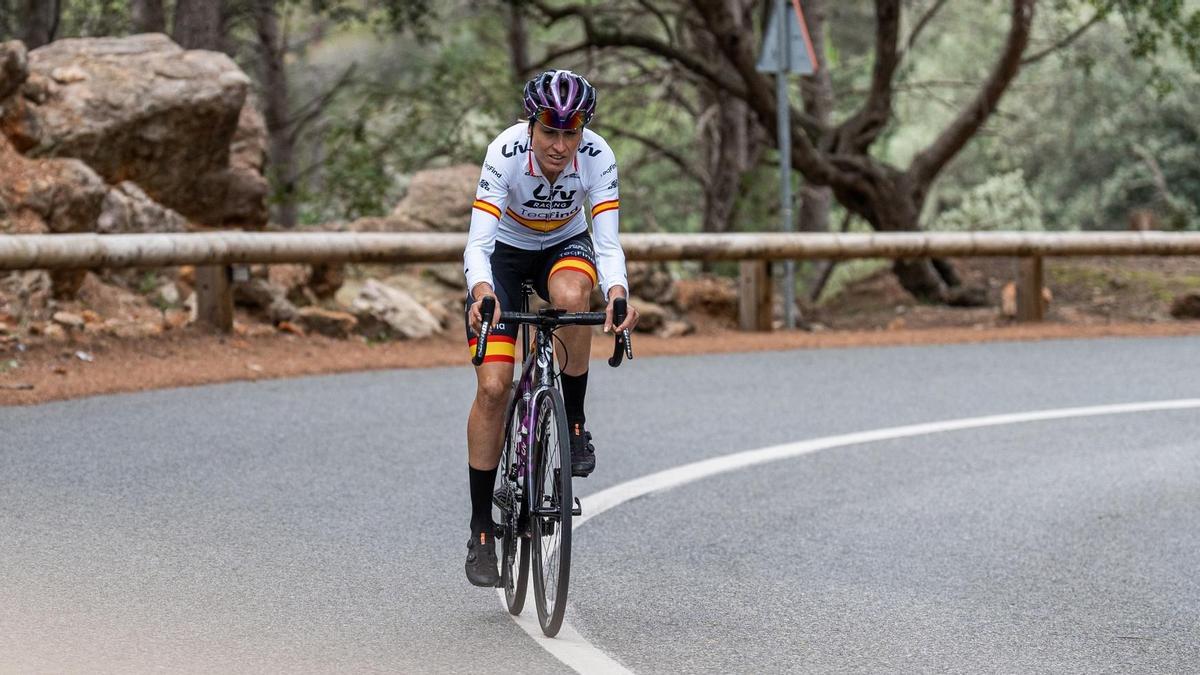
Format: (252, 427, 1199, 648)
(463, 231, 596, 363)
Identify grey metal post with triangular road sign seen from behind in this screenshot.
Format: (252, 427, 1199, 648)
(757, 0, 817, 329)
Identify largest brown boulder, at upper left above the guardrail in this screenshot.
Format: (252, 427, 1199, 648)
(23, 34, 266, 226)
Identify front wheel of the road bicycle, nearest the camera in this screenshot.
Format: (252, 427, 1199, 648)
(528, 389, 574, 638)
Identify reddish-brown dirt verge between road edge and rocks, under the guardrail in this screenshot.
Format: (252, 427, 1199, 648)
(0, 258, 1200, 405)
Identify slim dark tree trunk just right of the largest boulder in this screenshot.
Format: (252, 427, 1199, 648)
(254, 0, 296, 228)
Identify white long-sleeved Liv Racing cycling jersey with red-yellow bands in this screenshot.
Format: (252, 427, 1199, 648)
(463, 123, 629, 298)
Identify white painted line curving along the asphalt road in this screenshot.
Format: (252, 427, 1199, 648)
(499, 399, 1200, 675)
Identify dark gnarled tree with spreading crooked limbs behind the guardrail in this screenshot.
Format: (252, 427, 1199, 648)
(534, 0, 1036, 300)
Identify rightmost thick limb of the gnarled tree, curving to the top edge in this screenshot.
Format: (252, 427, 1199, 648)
(907, 0, 1037, 186)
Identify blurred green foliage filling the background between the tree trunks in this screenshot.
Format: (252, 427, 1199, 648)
(7, 0, 1200, 241)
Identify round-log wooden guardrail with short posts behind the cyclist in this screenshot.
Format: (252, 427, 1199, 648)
(0, 232, 1200, 329)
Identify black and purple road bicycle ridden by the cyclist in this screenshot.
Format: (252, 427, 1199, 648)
(472, 283, 634, 638)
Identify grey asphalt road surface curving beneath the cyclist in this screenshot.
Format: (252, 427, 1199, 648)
(0, 339, 1200, 673)
